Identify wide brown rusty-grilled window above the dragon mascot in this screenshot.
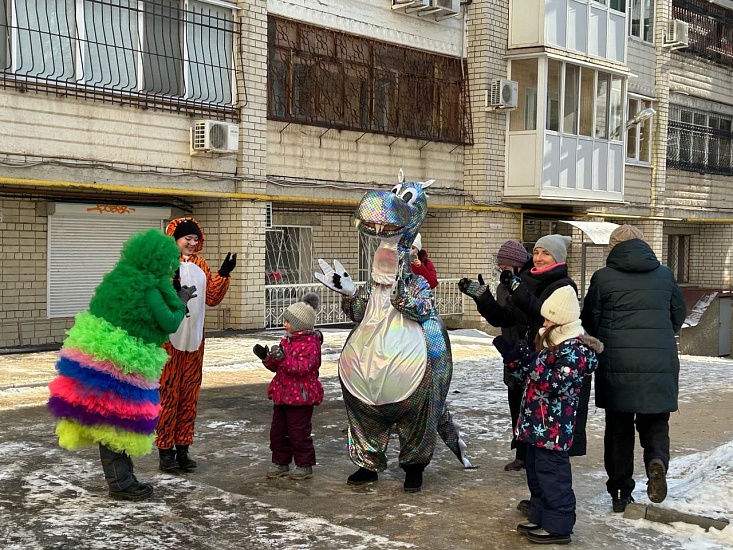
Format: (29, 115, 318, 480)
(267, 16, 473, 144)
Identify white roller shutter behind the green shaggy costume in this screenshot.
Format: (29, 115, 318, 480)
(48, 203, 171, 318)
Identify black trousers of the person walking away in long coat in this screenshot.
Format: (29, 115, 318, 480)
(603, 411, 669, 496)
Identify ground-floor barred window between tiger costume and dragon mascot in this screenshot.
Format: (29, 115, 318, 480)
(265, 227, 313, 285)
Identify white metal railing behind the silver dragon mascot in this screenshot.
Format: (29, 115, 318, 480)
(265, 279, 463, 328)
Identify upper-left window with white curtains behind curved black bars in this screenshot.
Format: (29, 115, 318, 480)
(0, 0, 237, 118)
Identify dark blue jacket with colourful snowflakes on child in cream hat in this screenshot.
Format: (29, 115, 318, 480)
(506, 335, 602, 451)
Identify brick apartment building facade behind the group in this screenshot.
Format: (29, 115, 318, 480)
(0, 0, 733, 348)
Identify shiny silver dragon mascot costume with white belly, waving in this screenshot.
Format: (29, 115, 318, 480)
(316, 173, 473, 492)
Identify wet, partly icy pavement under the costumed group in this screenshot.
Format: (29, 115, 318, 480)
(0, 330, 733, 550)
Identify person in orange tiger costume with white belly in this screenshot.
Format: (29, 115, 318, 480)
(155, 218, 237, 472)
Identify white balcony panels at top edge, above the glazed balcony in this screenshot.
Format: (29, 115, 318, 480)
(509, 0, 627, 64)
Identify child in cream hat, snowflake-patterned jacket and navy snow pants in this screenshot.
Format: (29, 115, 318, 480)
(494, 286, 603, 544)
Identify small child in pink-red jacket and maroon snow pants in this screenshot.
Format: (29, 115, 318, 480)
(252, 292, 323, 480)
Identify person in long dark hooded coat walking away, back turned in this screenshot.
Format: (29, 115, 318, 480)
(581, 225, 687, 513)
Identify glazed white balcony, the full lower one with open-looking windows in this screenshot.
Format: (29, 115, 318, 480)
(504, 55, 626, 203)
